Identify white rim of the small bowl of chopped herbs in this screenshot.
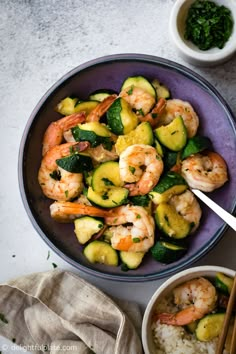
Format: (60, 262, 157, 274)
(169, 0, 236, 64)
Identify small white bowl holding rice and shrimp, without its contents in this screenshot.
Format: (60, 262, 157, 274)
(142, 265, 236, 354)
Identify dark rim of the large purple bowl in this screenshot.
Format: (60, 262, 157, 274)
(18, 53, 236, 282)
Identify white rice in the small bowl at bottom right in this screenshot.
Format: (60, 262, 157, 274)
(152, 297, 229, 354)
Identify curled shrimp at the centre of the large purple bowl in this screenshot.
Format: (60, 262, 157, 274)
(119, 144, 163, 196)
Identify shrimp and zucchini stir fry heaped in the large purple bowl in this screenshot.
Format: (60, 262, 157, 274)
(38, 76, 228, 270)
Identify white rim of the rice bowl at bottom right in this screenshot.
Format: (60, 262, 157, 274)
(141, 265, 236, 354)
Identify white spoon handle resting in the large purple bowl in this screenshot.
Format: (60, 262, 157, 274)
(192, 189, 236, 231)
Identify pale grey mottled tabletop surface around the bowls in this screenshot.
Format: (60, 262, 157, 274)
(0, 0, 236, 352)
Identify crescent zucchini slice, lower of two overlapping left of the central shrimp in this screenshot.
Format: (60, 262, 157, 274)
(87, 187, 129, 208)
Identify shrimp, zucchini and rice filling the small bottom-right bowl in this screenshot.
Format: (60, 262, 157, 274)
(152, 273, 235, 354)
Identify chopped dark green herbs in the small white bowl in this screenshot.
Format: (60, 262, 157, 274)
(184, 0, 234, 50)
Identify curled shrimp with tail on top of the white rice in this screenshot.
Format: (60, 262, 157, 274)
(155, 278, 217, 326)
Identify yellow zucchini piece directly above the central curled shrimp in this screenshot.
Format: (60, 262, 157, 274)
(115, 122, 153, 155)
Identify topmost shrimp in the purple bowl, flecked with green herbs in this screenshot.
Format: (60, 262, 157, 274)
(119, 85, 156, 115)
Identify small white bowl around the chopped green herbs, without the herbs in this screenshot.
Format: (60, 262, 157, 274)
(169, 0, 236, 66)
